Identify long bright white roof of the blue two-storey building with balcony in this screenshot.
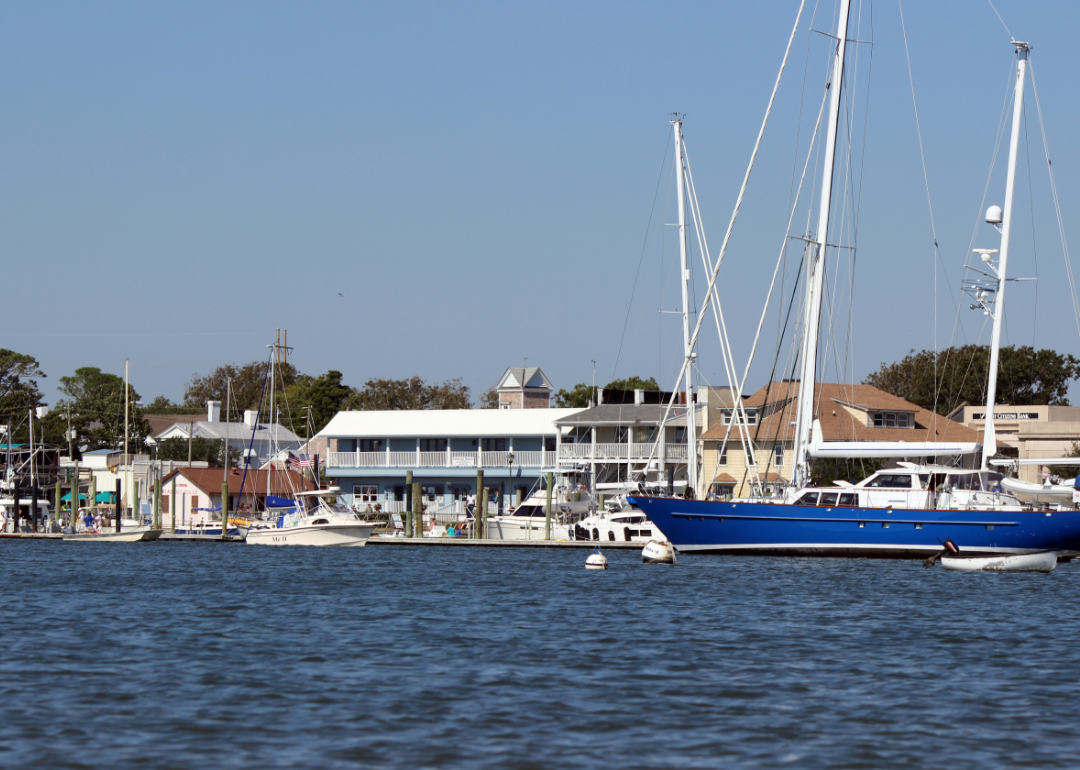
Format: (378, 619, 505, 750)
(319, 409, 581, 438)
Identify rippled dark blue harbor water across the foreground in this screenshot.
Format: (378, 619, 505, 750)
(0, 541, 1080, 770)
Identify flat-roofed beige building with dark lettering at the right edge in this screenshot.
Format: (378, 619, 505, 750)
(949, 405, 1080, 482)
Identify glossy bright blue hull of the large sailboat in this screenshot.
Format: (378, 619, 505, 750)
(631, 497, 1080, 558)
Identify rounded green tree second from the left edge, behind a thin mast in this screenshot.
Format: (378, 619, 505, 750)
(52, 366, 149, 454)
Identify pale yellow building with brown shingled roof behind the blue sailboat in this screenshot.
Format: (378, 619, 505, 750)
(702, 381, 978, 497)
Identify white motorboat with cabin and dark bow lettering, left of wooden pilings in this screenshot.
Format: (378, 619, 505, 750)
(244, 489, 378, 546)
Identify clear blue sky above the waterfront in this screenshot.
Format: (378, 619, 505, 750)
(0, 0, 1080, 401)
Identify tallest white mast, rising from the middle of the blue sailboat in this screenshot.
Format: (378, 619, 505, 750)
(794, 0, 851, 486)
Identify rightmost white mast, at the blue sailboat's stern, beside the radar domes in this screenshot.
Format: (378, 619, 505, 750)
(983, 40, 1031, 470)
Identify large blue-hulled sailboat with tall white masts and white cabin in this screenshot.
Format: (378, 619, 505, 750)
(630, 0, 1080, 558)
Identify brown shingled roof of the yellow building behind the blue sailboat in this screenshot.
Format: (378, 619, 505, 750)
(702, 382, 981, 445)
